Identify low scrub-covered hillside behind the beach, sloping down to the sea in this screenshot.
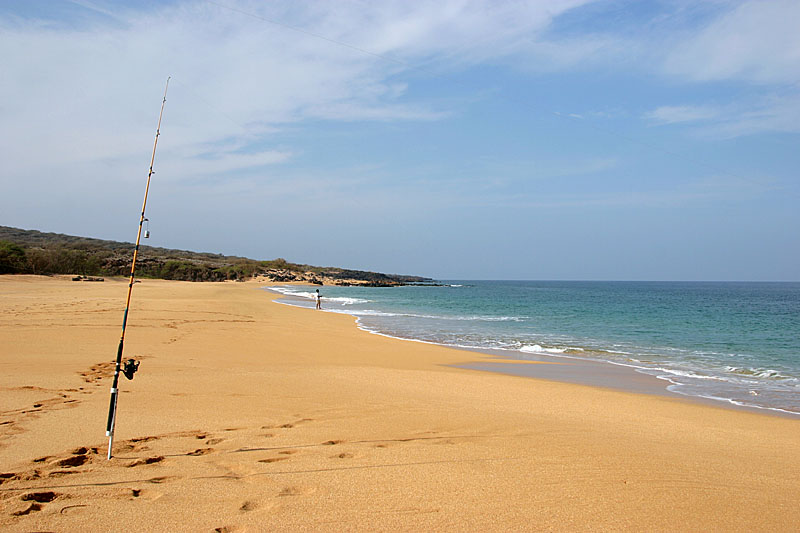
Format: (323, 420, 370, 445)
(0, 226, 432, 287)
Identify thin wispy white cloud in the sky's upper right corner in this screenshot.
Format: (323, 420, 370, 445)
(644, 0, 800, 138)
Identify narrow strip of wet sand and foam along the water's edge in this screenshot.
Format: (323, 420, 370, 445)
(270, 283, 800, 420)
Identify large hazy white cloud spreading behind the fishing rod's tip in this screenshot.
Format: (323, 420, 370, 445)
(0, 0, 587, 185)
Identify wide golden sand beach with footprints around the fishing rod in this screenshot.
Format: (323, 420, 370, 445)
(0, 276, 800, 531)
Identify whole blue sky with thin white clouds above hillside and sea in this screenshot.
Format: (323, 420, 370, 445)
(0, 0, 800, 281)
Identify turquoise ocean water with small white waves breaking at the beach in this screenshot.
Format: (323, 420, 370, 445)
(271, 281, 800, 414)
